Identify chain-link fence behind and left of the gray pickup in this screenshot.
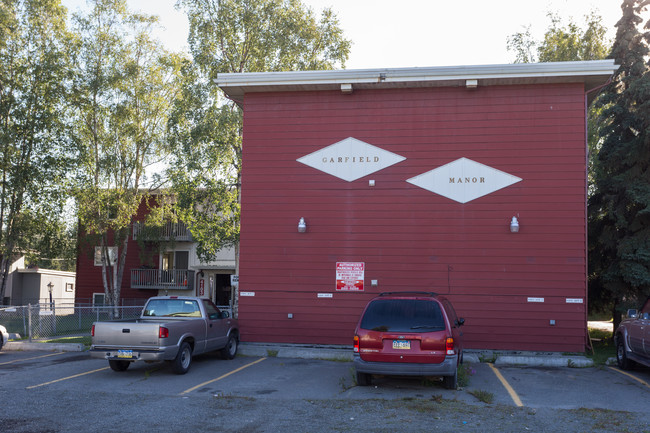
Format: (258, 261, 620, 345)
(0, 303, 142, 341)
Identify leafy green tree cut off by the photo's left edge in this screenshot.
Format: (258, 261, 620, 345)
(0, 0, 73, 301)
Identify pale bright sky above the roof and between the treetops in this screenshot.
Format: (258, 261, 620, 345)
(62, 0, 632, 69)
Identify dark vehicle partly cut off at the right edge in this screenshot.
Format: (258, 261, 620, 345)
(614, 298, 650, 370)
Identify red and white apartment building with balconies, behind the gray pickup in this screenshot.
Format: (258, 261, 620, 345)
(76, 197, 235, 308)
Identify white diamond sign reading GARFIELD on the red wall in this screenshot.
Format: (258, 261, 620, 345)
(296, 137, 406, 182)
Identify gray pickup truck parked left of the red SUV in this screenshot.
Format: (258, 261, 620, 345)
(90, 296, 239, 374)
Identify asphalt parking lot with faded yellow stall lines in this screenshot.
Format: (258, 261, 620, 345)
(0, 351, 650, 433)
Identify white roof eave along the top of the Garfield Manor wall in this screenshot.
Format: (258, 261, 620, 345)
(216, 59, 618, 102)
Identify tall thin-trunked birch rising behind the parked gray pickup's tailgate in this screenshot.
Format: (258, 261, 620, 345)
(75, 0, 181, 305)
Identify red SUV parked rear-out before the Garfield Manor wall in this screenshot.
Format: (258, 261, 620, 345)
(354, 292, 465, 389)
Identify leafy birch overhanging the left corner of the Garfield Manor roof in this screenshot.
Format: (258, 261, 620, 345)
(170, 0, 350, 262)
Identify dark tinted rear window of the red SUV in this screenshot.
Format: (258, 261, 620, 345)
(360, 299, 445, 332)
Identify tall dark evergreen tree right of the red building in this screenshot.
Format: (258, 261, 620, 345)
(589, 0, 650, 325)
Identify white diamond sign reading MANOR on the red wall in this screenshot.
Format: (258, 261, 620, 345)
(407, 158, 522, 203)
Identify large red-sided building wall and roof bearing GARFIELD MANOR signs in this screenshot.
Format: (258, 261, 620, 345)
(218, 60, 616, 351)
